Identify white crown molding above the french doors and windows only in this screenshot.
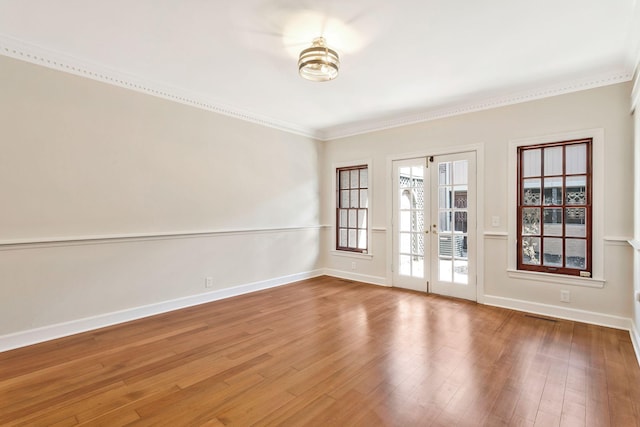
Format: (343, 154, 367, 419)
(316, 70, 633, 141)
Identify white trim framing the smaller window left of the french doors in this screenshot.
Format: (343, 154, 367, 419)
(329, 158, 374, 259)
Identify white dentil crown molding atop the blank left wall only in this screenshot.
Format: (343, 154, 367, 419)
(0, 34, 316, 138)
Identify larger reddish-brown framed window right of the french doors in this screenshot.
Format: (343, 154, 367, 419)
(517, 139, 592, 277)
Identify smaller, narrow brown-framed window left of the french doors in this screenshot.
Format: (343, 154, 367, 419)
(336, 165, 369, 254)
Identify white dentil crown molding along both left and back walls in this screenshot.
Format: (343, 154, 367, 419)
(0, 34, 637, 141)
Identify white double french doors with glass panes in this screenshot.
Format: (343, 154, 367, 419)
(392, 153, 476, 301)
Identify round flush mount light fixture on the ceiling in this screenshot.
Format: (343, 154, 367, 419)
(298, 37, 340, 82)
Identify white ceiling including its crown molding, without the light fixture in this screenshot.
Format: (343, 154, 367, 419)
(0, 0, 640, 139)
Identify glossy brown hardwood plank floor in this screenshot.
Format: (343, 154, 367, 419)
(0, 277, 640, 427)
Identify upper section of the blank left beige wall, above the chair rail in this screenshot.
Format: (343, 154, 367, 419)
(0, 57, 319, 240)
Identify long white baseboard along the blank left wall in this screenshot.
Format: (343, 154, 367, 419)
(0, 270, 323, 352)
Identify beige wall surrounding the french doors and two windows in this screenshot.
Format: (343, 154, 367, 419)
(321, 84, 633, 319)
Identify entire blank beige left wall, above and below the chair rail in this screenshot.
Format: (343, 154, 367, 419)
(0, 56, 321, 336)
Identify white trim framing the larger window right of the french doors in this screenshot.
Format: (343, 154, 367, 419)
(507, 128, 605, 288)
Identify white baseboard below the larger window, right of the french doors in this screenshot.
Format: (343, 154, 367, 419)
(483, 295, 632, 331)
